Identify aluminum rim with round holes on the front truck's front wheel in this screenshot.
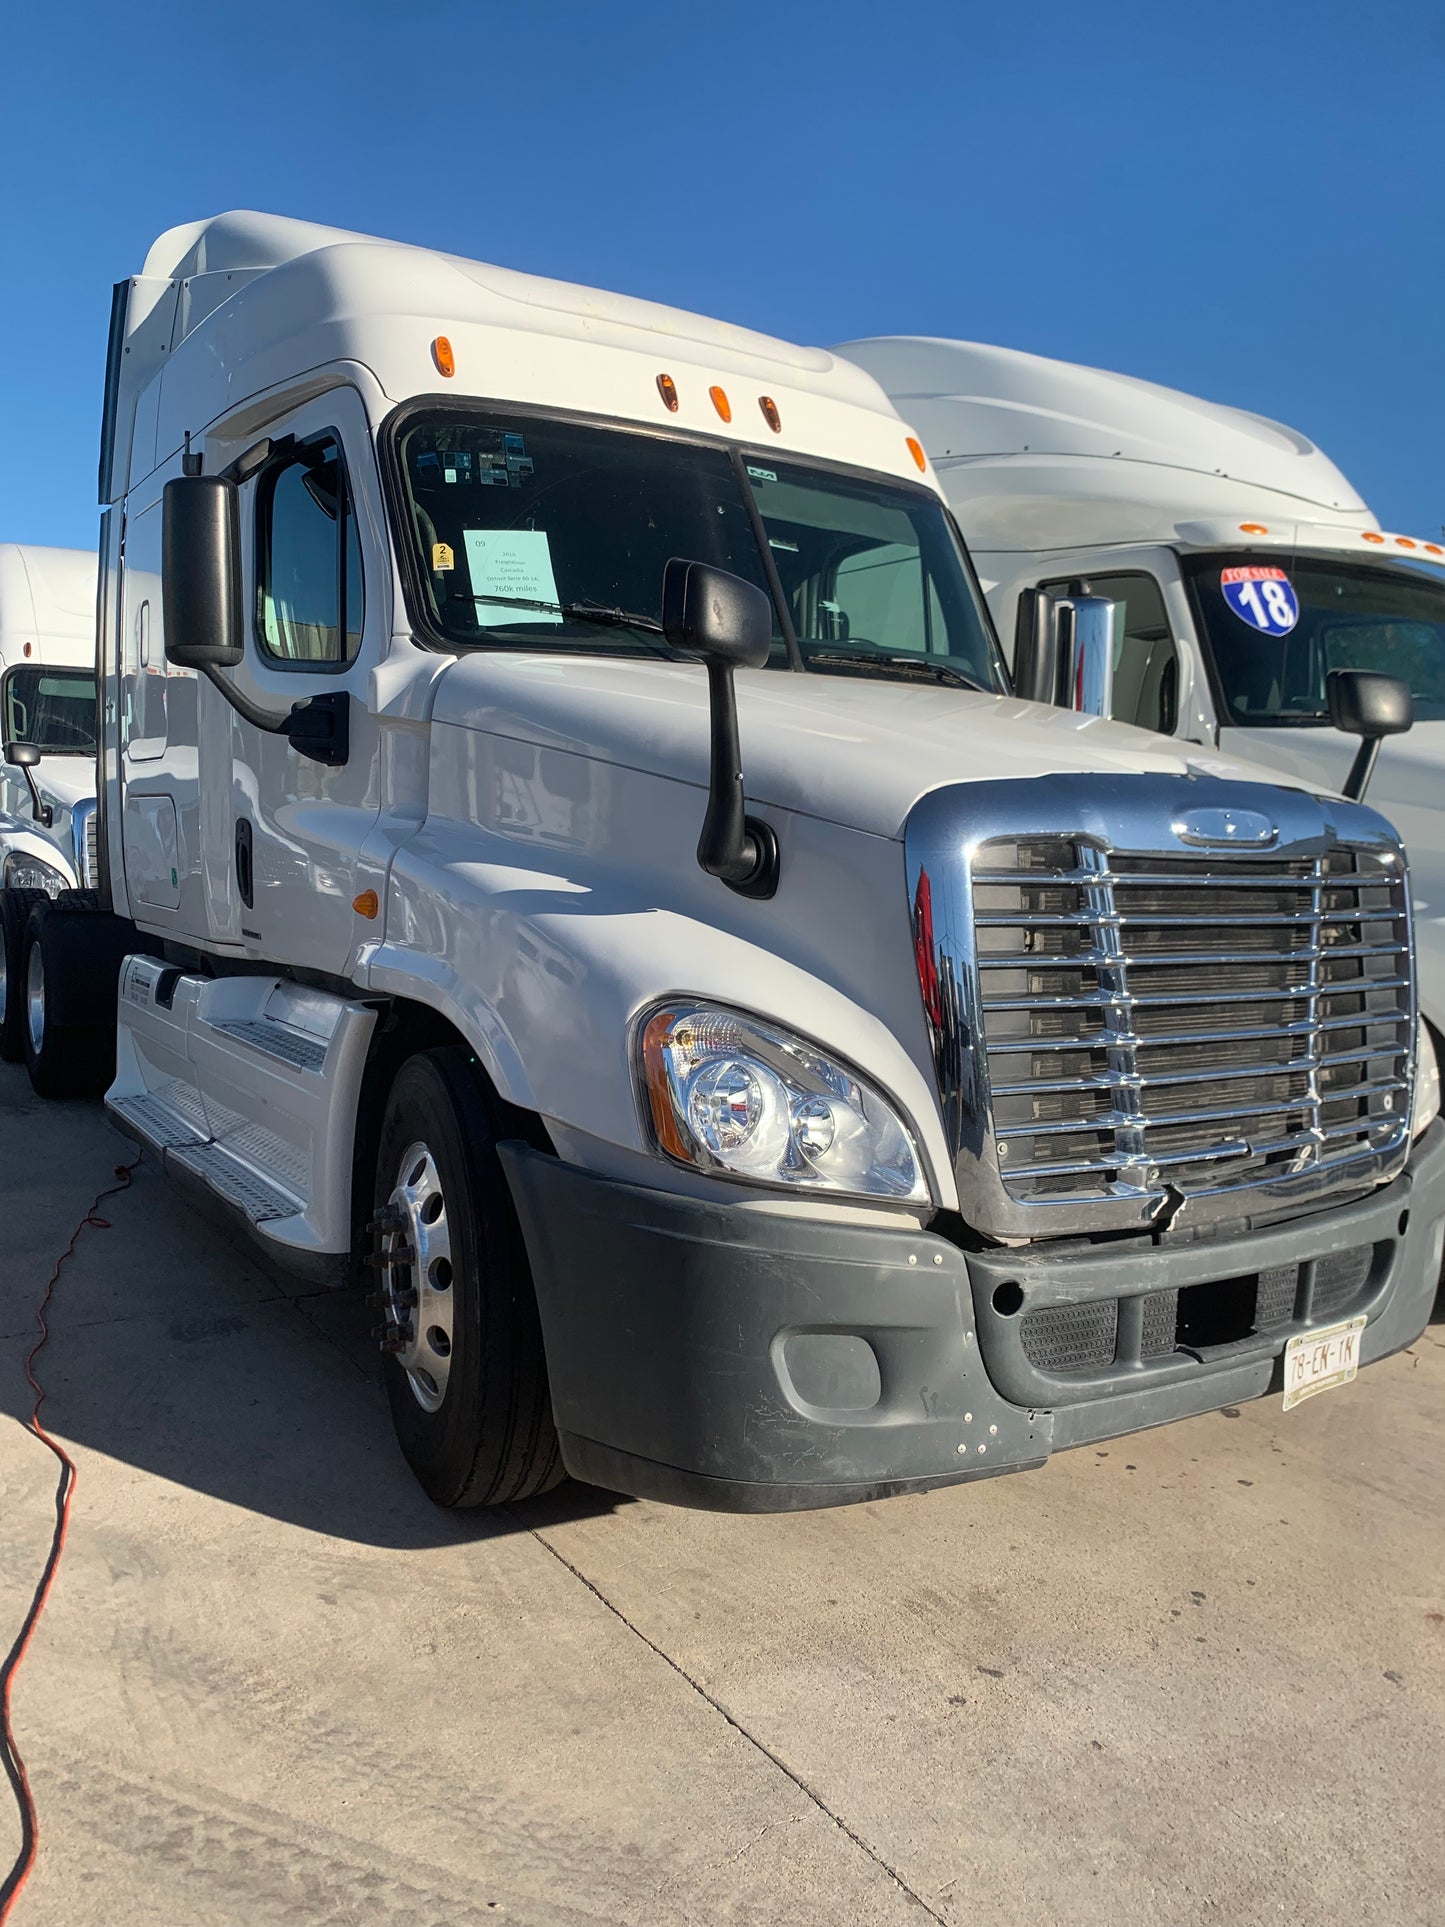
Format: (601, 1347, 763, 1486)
(381, 1139, 457, 1412)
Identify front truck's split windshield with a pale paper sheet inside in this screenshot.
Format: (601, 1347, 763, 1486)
(397, 409, 1004, 690)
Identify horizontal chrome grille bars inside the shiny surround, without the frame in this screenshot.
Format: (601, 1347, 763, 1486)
(973, 838, 1410, 1202)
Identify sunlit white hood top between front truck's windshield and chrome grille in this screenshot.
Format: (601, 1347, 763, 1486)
(432, 651, 1312, 836)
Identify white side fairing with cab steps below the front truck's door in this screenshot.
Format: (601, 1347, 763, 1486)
(106, 956, 376, 1278)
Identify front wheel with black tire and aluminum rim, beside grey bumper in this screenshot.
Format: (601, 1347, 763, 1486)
(372, 1046, 563, 1507)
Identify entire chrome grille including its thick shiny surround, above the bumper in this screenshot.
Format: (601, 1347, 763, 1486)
(907, 777, 1414, 1235)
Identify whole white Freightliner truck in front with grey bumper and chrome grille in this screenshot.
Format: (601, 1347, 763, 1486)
(16, 214, 1445, 1509)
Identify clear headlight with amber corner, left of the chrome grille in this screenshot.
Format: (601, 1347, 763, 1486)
(642, 1002, 929, 1204)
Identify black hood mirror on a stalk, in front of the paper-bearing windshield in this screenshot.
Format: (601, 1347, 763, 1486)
(663, 557, 778, 896)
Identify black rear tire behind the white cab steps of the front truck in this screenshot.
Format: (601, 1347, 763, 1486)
(17, 896, 135, 1096)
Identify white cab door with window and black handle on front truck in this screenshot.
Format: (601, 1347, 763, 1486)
(202, 389, 391, 975)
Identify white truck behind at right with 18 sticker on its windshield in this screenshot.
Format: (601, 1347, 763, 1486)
(836, 335, 1445, 1039)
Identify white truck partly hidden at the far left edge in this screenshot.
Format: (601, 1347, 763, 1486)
(0, 541, 96, 1062)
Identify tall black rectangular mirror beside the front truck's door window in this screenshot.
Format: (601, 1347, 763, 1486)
(160, 476, 245, 673)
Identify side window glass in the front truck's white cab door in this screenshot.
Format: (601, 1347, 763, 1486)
(256, 436, 362, 669)
